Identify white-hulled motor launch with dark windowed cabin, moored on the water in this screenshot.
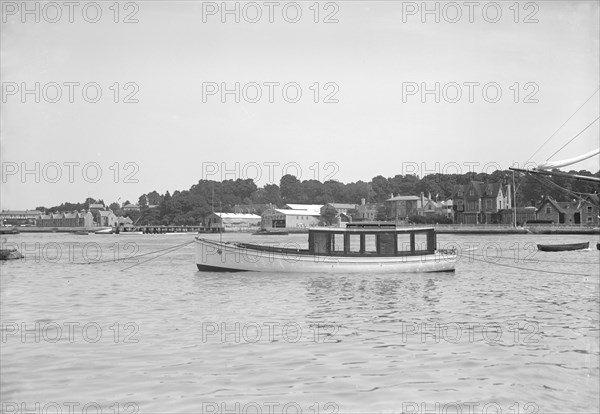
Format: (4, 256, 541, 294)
(196, 226, 457, 274)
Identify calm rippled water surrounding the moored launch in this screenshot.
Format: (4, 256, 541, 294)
(0, 234, 600, 413)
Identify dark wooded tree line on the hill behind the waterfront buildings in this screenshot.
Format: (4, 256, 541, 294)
(37, 170, 600, 225)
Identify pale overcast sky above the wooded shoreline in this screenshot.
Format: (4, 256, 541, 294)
(1, 1, 600, 209)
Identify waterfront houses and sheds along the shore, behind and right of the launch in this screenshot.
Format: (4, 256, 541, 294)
(209, 181, 600, 231)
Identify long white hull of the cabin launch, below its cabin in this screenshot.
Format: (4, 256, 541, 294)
(196, 238, 456, 273)
